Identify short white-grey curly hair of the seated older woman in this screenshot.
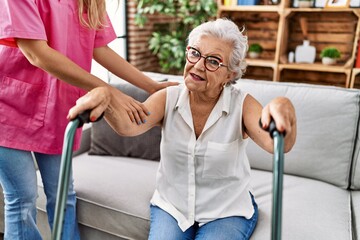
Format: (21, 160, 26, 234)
(188, 18, 248, 82)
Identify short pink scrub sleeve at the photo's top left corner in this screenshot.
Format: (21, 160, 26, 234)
(0, 0, 47, 46)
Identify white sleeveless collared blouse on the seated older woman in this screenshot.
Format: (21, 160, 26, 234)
(151, 84, 254, 231)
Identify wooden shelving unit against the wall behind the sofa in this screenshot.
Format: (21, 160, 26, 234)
(218, 0, 360, 88)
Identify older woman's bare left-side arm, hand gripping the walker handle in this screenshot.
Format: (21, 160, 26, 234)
(68, 86, 166, 136)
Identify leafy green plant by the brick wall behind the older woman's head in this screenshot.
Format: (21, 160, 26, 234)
(135, 0, 217, 74)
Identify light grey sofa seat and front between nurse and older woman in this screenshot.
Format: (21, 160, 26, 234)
(38, 153, 159, 240)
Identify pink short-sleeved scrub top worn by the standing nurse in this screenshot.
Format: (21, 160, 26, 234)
(0, 0, 116, 154)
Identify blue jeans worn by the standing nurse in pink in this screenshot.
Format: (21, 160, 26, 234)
(0, 147, 80, 240)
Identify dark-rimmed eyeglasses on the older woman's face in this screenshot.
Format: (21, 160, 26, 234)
(186, 46, 228, 72)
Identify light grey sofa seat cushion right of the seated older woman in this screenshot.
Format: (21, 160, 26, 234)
(251, 170, 352, 240)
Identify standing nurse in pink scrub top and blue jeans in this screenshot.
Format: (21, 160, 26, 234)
(0, 0, 175, 240)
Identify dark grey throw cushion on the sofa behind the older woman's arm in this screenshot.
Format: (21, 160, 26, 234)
(89, 83, 161, 160)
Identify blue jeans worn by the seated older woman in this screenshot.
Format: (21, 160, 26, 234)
(149, 194, 258, 240)
